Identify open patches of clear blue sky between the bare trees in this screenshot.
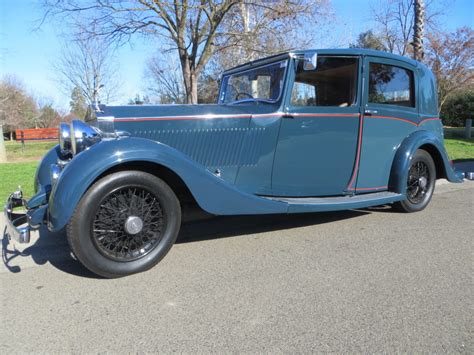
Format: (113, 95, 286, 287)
(0, 0, 474, 110)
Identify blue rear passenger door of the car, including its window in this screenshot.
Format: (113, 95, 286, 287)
(356, 56, 419, 193)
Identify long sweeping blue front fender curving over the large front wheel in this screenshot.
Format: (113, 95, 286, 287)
(48, 138, 287, 231)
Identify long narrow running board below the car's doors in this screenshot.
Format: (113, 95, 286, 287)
(262, 191, 405, 213)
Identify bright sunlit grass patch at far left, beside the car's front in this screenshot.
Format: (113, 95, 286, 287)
(0, 161, 39, 203)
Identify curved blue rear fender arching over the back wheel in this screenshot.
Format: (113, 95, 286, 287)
(389, 131, 462, 194)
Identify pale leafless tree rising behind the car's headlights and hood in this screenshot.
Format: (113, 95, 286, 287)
(53, 34, 118, 110)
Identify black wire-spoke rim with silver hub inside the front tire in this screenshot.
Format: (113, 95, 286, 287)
(92, 186, 164, 262)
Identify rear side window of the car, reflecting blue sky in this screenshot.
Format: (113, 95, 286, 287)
(369, 63, 415, 107)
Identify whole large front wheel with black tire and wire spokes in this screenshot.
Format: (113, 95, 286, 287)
(67, 171, 181, 278)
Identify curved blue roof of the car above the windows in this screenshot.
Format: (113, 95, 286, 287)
(223, 48, 419, 75)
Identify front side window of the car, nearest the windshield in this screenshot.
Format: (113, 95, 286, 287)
(291, 56, 358, 107)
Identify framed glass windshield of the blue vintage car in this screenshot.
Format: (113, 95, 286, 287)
(219, 60, 287, 104)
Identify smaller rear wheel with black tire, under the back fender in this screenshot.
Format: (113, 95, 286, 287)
(394, 149, 436, 212)
